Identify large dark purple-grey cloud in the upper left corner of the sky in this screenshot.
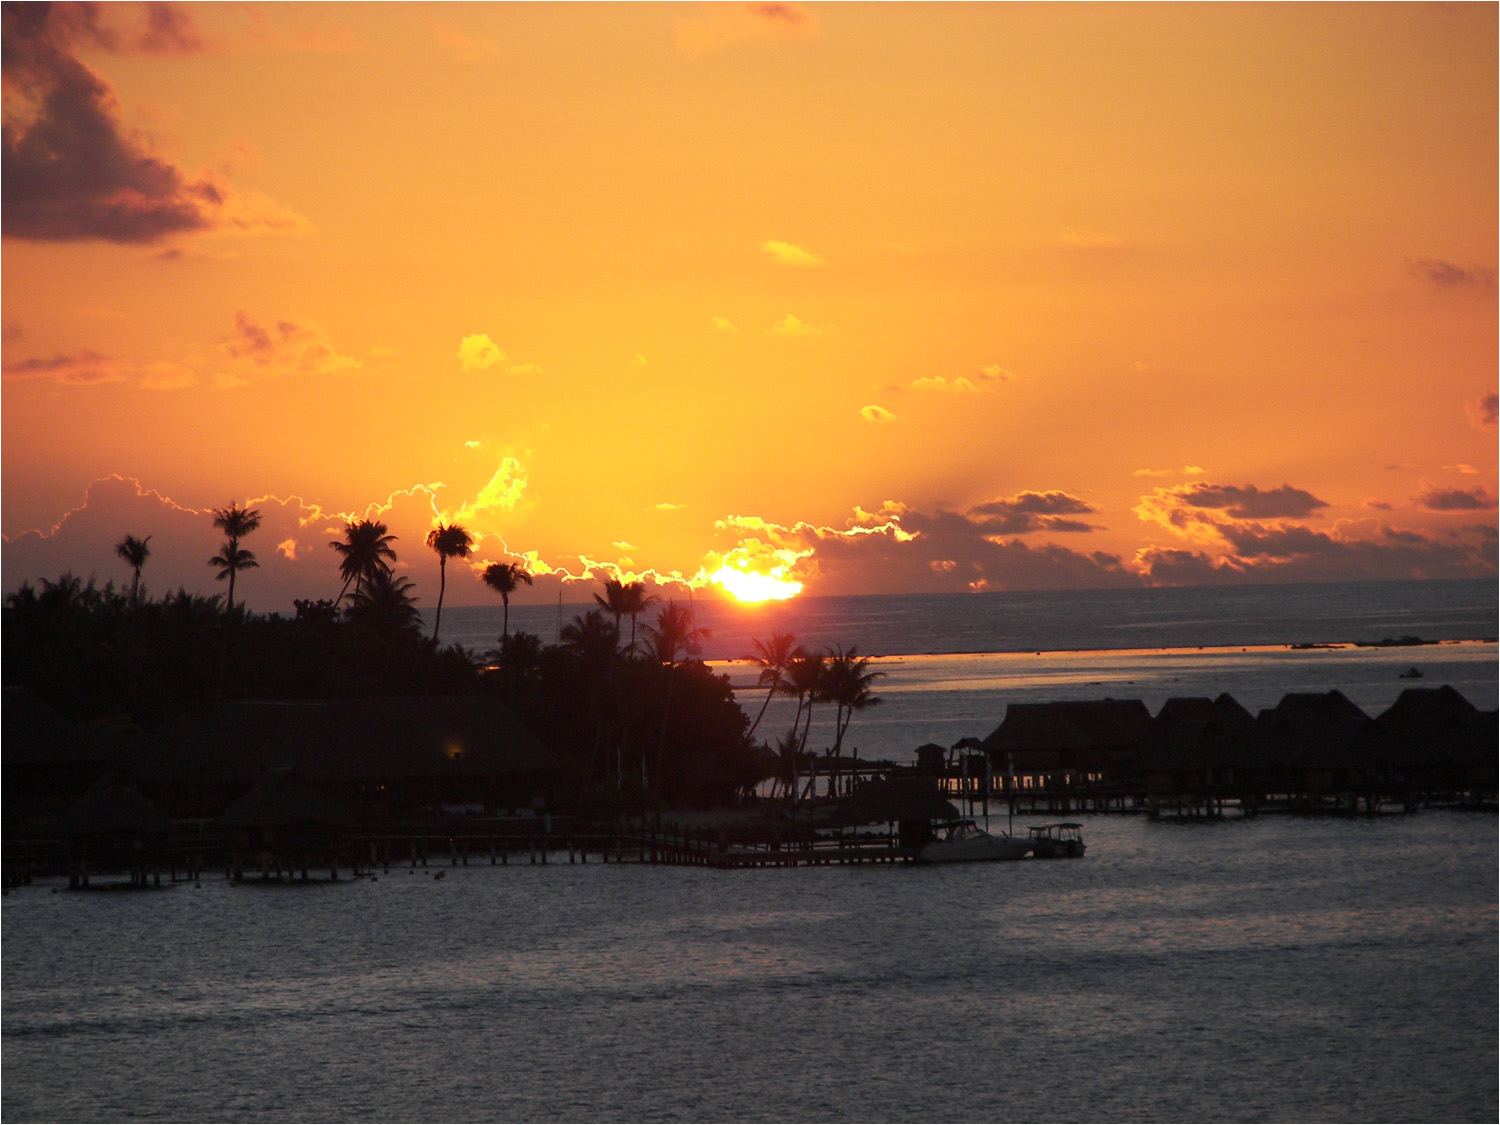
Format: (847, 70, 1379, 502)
(0, 5, 308, 245)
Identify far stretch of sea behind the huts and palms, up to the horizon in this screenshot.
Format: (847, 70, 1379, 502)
(443, 581, 1500, 762)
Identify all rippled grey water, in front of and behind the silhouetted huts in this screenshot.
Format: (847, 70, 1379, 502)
(0, 582, 1500, 1122)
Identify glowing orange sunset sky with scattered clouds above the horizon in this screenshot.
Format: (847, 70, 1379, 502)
(0, 3, 1500, 612)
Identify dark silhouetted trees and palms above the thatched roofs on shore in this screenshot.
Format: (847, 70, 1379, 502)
(0, 507, 879, 812)
